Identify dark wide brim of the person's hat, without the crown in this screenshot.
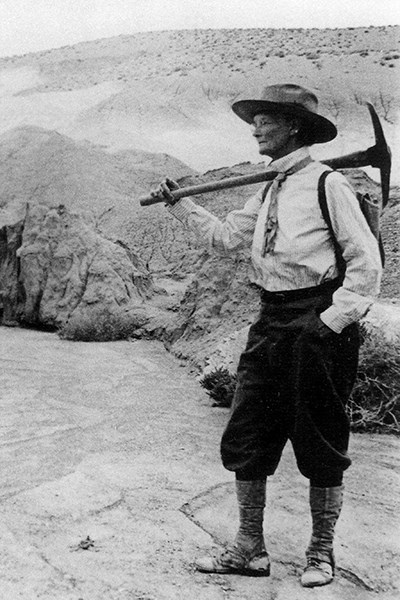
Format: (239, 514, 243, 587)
(232, 100, 337, 144)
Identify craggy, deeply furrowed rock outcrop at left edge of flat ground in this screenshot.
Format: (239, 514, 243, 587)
(0, 204, 175, 337)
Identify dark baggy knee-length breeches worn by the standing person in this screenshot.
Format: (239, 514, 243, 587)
(221, 292, 359, 479)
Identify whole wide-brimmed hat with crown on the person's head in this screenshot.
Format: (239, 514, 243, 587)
(232, 83, 337, 144)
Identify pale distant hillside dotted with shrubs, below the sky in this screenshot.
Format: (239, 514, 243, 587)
(0, 26, 400, 176)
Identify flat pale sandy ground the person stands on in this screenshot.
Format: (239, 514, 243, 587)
(0, 328, 400, 600)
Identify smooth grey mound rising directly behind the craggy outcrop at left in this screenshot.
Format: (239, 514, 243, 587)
(0, 126, 193, 237)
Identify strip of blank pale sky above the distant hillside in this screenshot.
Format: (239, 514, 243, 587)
(0, 0, 400, 56)
